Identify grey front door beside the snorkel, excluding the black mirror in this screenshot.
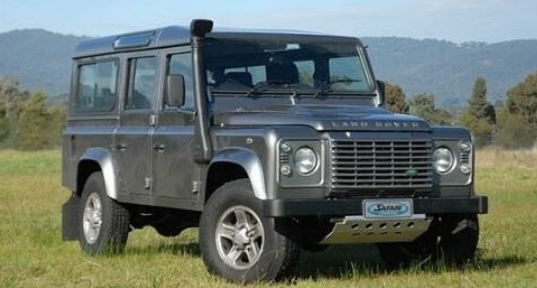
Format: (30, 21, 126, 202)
(152, 47, 195, 200)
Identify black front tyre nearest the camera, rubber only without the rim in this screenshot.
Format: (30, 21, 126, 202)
(199, 179, 300, 283)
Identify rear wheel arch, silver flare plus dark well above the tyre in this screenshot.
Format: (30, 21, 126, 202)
(76, 148, 118, 199)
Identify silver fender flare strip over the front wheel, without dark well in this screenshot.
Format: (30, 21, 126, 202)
(207, 148, 268, 200)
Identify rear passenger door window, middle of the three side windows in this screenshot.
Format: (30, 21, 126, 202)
(125, 57, 157, 110)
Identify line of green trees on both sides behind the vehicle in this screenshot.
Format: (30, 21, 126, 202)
(0, 71, 537, 150)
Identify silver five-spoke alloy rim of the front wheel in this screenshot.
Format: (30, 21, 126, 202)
(215, 206, 265, 270)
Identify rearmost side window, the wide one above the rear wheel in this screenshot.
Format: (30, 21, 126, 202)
(74, 61, 118, 113)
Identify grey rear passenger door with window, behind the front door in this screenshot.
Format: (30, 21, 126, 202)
(114, 53, 159, 195)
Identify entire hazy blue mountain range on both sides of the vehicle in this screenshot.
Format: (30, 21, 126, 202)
(0, 29, 537, 107)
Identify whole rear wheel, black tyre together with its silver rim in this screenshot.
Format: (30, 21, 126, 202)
(78, 172, 130, 256)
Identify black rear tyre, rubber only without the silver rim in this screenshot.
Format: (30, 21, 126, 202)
(78, 172, 130, 256)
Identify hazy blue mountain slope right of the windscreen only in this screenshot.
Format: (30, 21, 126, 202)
(362, 37, 537, 106)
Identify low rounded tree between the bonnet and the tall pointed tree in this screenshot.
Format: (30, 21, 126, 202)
(409, 93, 453, 125)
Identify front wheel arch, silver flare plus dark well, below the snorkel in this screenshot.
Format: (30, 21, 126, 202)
(204, 148, 268, 202)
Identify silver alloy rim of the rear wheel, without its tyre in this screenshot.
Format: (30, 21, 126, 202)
(82, 192, 103, 244)
